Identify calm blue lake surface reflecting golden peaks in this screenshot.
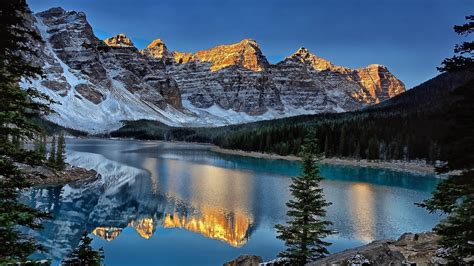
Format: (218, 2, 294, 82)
(25, 139, 441, 265)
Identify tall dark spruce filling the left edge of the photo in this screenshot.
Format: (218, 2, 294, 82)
(0, 0, 50, 264)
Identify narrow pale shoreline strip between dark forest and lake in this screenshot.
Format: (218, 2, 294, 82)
(210, 146, 440, 177)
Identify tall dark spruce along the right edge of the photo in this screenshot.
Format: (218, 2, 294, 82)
(418, 16, 474, 263)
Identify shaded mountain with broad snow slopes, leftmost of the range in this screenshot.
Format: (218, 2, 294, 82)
(22, 5, 182, 132)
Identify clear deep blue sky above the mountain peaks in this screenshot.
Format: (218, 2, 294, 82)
(28, 0, 474, 88)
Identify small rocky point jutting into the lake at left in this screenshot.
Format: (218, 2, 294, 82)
(20, 165, 97, 187)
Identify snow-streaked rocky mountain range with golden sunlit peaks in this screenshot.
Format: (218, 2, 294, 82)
(23, 8, 405, 132)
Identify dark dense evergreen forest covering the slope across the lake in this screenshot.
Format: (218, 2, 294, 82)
(111, 72, 474, 163)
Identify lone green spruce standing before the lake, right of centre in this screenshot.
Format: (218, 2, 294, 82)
(275, 138, 332, 265)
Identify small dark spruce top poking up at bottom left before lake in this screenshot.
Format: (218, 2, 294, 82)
(63, 231, 104, 266)
